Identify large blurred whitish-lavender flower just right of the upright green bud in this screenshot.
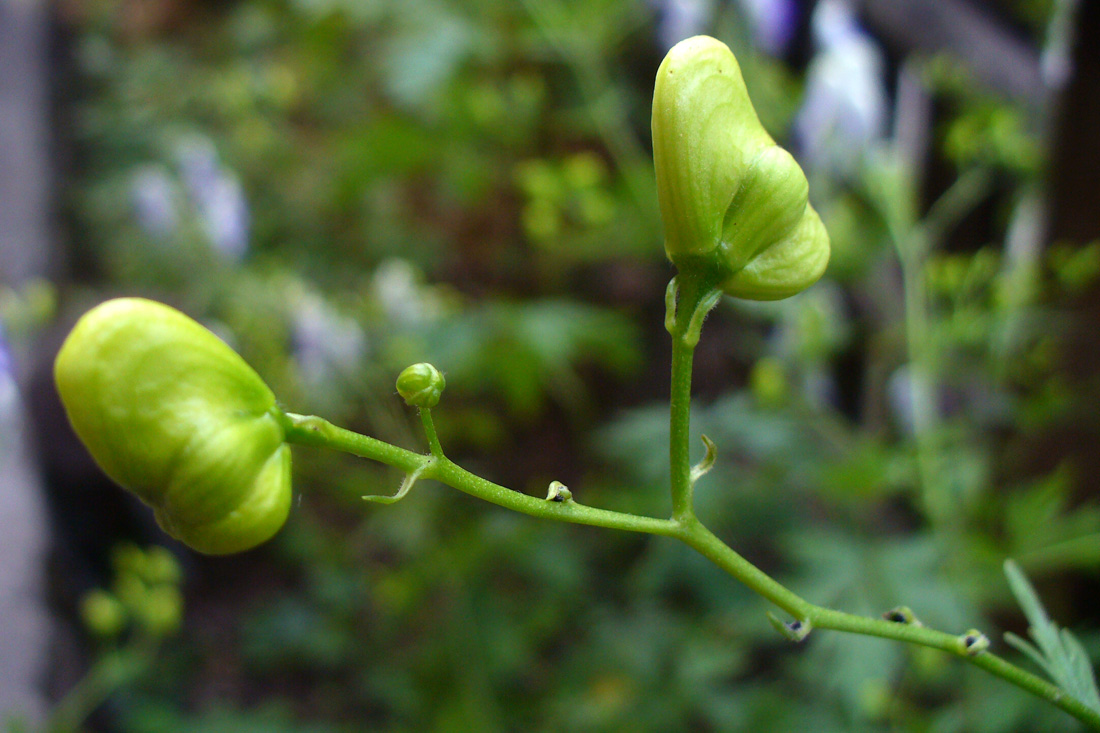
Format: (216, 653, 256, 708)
(794, 0, 888, 176)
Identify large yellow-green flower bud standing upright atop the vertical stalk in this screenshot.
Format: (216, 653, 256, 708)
(652, 35, 829, 300)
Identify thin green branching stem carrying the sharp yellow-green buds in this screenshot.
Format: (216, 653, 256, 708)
(281, 272, 1100, 731)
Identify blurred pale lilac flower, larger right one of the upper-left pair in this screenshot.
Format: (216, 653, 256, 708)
(176, 136, 251, 262)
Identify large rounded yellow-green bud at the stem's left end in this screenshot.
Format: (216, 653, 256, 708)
(54, 298, 290, 555)
